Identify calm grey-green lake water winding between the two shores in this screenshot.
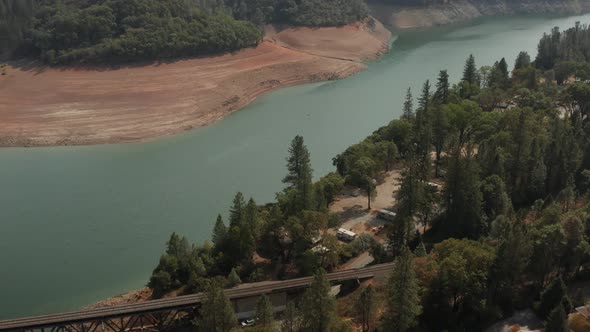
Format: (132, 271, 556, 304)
(0, 15, 590, 319)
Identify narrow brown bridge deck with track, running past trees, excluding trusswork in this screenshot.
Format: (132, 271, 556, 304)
(0, 263, 393, 331)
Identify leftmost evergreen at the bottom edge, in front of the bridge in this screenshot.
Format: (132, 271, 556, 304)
(197, 280, 238, 332)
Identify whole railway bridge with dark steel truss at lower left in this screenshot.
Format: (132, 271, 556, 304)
(0, 263, 393, 332)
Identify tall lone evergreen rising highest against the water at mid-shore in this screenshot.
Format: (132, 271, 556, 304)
(283, 135, 313, 213)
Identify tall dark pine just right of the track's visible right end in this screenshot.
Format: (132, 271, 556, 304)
(385, 248, 422, 332)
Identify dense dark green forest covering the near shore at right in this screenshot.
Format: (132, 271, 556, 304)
(149, 24, 590, 332)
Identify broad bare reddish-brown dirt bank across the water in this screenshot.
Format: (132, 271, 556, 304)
(0, 19, 391, 146)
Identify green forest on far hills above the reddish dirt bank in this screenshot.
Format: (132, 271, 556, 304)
(0, 0, 367, 64)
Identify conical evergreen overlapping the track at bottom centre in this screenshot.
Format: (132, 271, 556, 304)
(301, 268, 336, 332)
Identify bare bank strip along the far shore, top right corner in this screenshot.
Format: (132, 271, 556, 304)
(370, 0, 590, 29)
